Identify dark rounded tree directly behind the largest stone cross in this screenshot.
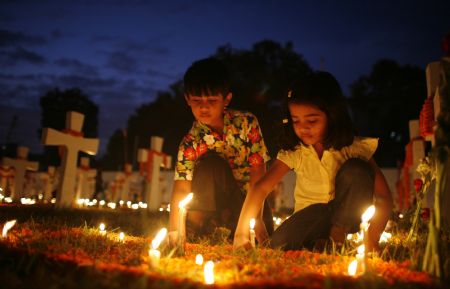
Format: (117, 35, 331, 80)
(38, 88, 98, 166)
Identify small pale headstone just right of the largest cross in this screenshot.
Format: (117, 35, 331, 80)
(75, 157, 97, 200)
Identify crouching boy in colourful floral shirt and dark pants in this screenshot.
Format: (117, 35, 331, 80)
(169, 58, 273, 243)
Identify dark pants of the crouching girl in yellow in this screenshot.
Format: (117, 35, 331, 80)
(271, 158, 375, 250)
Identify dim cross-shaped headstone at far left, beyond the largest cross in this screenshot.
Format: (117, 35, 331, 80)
(3, 146, 39, 201)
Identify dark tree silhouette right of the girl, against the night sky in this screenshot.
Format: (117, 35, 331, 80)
(349, 60, 427, 167)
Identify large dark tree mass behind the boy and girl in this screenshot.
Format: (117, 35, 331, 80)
(102, 40, 311, 169)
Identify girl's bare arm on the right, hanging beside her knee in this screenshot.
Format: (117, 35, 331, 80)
(367, 159, 393, 251)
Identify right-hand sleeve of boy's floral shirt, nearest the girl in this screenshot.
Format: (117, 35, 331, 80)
(247, 114, 270, 167)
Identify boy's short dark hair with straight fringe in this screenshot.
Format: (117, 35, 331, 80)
(183, 57, 231, 97)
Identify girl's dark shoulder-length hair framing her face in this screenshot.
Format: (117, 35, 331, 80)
(279, 71, 356, 150)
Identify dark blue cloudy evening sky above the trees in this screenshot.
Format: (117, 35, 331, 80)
(0, 0, 450, 153)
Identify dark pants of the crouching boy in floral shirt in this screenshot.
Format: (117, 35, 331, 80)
(187, 153, 273, 238)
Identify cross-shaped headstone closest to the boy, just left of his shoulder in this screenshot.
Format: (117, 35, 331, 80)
(138, 136, 172, 211)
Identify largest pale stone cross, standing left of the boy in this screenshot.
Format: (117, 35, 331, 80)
(42, 111, 99, 207)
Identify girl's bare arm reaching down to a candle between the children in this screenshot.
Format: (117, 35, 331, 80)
(233, 160, 289, 248)
